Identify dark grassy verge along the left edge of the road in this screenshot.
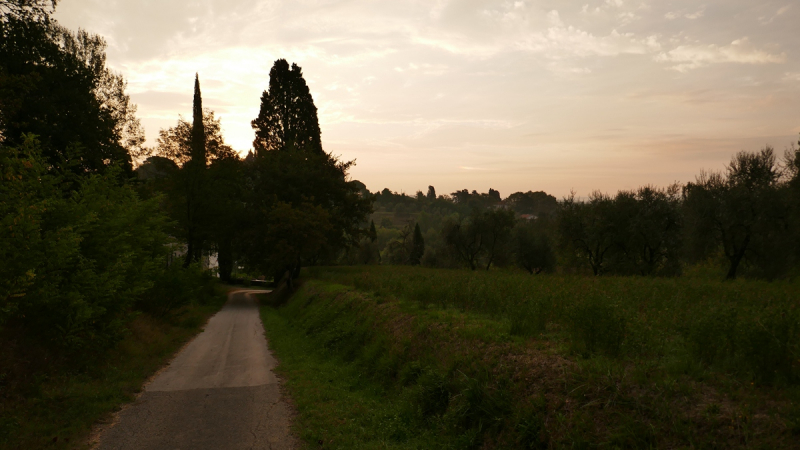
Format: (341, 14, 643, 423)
(0, 286, 227, 449)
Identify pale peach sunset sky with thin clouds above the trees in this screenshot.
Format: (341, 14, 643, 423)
(55, 0, 800, 198)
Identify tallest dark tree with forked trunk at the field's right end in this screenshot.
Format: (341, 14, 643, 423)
(683, 146, 787, 279)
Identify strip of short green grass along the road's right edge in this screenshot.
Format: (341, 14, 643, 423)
(261, 292, 441, 449)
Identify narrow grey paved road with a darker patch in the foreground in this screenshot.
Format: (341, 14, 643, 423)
(97, 291, 297, 450)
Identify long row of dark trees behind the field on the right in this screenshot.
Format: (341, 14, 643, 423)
(354, 146, 800, 279)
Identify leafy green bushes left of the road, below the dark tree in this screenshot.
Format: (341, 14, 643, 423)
(0, 136, 167, 351)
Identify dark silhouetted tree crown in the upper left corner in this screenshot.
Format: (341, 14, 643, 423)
(0, 11, 144, 175)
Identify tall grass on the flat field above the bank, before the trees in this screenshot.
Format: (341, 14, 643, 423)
(309, 266, 800, 385)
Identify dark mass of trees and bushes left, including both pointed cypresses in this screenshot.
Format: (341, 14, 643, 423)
(0, 0, 371, 360)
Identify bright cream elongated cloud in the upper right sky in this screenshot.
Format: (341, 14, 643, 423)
(655, 37, 786, 72)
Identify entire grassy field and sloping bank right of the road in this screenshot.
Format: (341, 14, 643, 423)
(263, 267, 800, 448)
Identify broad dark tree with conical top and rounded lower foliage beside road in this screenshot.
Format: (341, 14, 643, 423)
(246, 59, 373, 279)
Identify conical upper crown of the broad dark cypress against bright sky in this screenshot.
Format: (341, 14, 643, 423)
(252, 59, 322, 154)
